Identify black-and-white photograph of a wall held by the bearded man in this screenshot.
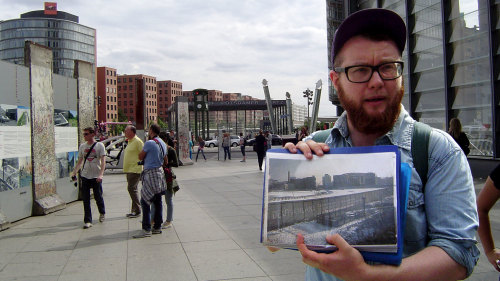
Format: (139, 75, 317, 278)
(262, 152, 397, 252)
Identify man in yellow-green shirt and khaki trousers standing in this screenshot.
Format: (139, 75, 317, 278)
(123, 125, 144, 218)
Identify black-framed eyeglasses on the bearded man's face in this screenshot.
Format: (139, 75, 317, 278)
(333, 61, 404, 83)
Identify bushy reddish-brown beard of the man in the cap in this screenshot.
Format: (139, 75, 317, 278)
(338, 82, 404, 134)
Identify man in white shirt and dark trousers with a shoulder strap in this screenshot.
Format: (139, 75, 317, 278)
(70, 127, 106, 229)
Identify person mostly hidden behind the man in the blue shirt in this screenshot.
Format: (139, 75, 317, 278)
(160, 132, 179, 229)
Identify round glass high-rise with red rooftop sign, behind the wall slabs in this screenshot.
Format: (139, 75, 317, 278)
(0, 10, 96, 77)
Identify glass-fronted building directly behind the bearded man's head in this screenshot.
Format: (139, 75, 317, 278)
(326, 0, 500, 163)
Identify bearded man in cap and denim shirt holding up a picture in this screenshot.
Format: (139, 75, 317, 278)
(285, 9, 479, 280)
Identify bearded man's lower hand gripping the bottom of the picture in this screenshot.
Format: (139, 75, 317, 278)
(297, 234, 370, 280)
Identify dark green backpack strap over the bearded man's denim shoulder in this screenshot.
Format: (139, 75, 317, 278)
(411, 122, 431, 189)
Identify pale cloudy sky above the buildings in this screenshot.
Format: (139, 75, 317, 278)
(0, 0, 335, 116)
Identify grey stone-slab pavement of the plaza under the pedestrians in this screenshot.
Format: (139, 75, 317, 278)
(0, 149, 500, 281)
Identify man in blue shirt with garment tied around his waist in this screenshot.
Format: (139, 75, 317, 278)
(133, 124, 168, 238)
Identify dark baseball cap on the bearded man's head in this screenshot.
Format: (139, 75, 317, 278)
(332, 9, 406, 65)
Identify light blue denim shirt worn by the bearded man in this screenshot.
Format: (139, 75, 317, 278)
(305, 106, 479, 280)
